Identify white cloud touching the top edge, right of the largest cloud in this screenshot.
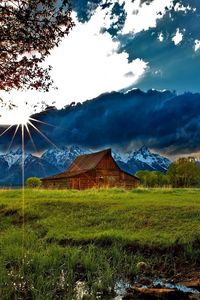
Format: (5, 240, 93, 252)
(120, 0, 173, 34)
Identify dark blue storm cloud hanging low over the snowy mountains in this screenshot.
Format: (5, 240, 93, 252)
(1, 90, 200, 154)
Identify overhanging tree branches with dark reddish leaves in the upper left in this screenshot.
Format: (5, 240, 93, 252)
(0, 0, 74, 91)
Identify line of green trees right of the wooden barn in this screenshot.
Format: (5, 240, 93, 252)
(136, 157, 200, 187)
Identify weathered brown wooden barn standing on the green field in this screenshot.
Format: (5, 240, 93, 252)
(42, 149, 139, 190)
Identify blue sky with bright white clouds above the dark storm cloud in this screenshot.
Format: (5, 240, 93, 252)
(0, 0, 200, 124)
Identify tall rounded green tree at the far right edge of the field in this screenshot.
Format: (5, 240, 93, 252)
(167, 157, 200, 187)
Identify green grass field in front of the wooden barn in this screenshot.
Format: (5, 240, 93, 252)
(0, 189, 200, 300)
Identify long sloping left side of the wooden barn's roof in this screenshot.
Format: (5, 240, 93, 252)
(44, 149, 111, 180)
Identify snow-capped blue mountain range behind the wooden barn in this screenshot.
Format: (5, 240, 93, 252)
(0, 146, 171, 186)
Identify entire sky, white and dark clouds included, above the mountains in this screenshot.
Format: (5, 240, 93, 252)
(0, 0, 200, 156)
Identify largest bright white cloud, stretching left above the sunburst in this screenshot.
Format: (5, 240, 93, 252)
(0, 8, 147, 123)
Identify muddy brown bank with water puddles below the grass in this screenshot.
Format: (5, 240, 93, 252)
(75, 272, 200, 300)
